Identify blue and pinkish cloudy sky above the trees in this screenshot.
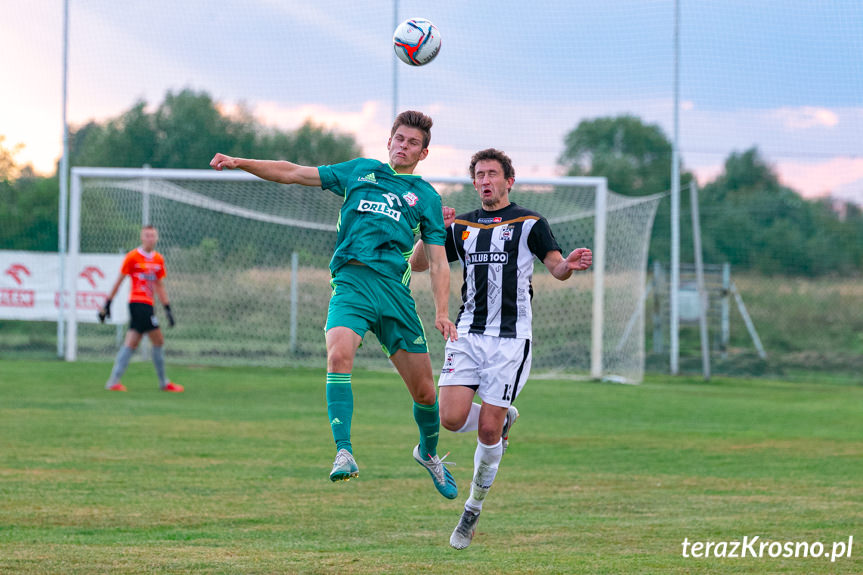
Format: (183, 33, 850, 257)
(0, 0, 863, 203)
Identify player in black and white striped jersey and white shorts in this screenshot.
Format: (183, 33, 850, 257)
(411, 148, 593, 549)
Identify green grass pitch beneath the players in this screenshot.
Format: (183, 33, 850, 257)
(0, 361, 863, 574)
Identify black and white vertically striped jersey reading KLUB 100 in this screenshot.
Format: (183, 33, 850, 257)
(446, 203, 561, 339)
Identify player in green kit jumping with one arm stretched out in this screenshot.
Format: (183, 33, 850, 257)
(210, 111, 458, 499)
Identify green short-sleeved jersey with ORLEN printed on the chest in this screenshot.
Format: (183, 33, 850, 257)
(318, 158, 446, 285)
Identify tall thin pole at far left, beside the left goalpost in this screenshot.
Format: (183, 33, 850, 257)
(56, 0, 70, 357)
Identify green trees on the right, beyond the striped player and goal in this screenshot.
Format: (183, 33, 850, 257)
(559, 115, 863, 276)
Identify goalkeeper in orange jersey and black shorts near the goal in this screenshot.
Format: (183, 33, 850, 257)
(99, 226, 183, 393)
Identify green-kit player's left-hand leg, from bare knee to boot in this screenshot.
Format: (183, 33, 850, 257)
(327, 327, 362, 481)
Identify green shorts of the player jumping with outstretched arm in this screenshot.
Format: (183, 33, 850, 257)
(326, 264, 428, 356)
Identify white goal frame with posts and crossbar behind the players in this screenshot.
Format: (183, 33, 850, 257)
(66, 167, 646, 380)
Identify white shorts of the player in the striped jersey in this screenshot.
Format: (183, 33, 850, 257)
(438, 333, 531, 407)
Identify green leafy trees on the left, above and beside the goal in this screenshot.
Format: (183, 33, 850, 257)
(0, 89, 360, 253)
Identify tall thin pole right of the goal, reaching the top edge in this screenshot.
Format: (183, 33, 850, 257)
(669, 0, 680, 375)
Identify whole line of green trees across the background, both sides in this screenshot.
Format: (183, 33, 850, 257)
(0, 93, 863, 275)
